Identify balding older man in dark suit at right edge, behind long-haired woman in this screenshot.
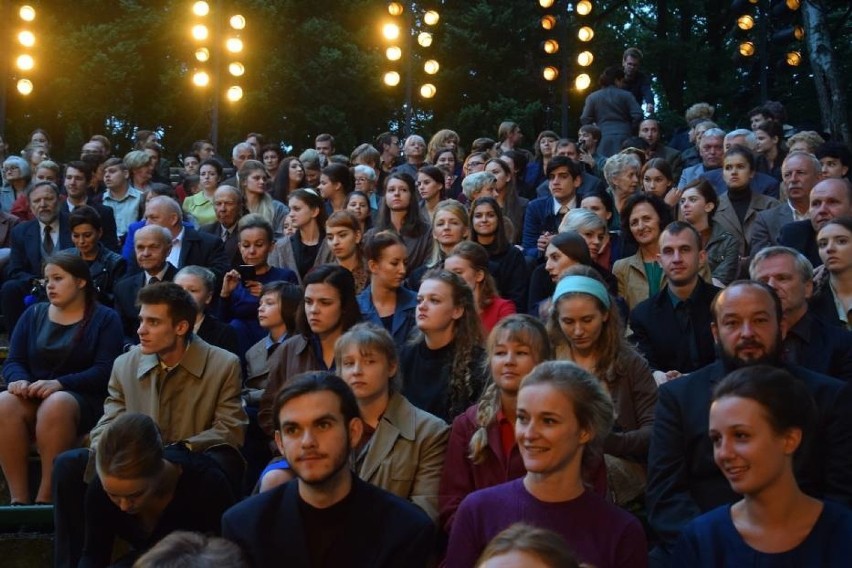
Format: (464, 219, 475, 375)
(778, 178, 852, 267)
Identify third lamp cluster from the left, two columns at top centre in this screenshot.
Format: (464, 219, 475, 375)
(382, 2, 441, 99)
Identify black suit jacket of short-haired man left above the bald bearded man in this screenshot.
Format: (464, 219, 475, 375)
(630, 277, 721, 373)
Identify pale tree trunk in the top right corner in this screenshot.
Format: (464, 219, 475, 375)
(802, 0, 850, 145)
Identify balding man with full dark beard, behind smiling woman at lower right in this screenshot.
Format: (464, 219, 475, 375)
(647, 280, 852, 566)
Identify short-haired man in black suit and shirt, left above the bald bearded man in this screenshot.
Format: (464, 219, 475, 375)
(630, 221, 720, 384)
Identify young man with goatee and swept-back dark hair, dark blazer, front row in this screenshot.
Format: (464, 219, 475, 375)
(222, 372, 435, 568)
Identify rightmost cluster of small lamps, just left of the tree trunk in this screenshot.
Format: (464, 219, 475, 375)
(731, 0, 805, 67)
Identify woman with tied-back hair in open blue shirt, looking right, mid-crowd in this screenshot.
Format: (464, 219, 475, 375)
(358, 231, 417, 349)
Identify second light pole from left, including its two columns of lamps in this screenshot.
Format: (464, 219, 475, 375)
(191, 0, 246, 147)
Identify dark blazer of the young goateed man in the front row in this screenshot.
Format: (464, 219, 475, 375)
(222, 475, 435, 568)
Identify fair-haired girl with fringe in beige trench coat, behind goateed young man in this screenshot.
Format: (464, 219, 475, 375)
(334, 323, 449, 521)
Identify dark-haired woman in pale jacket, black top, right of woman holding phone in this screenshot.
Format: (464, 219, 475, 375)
(269, 189, 334, 284)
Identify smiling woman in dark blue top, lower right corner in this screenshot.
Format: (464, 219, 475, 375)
(672, 366, 852, 568)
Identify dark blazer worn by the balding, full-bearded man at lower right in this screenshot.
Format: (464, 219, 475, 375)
(647, 360, 852, 548)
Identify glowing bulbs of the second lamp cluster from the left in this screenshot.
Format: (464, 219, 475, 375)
(192, 0, 246, 102)
